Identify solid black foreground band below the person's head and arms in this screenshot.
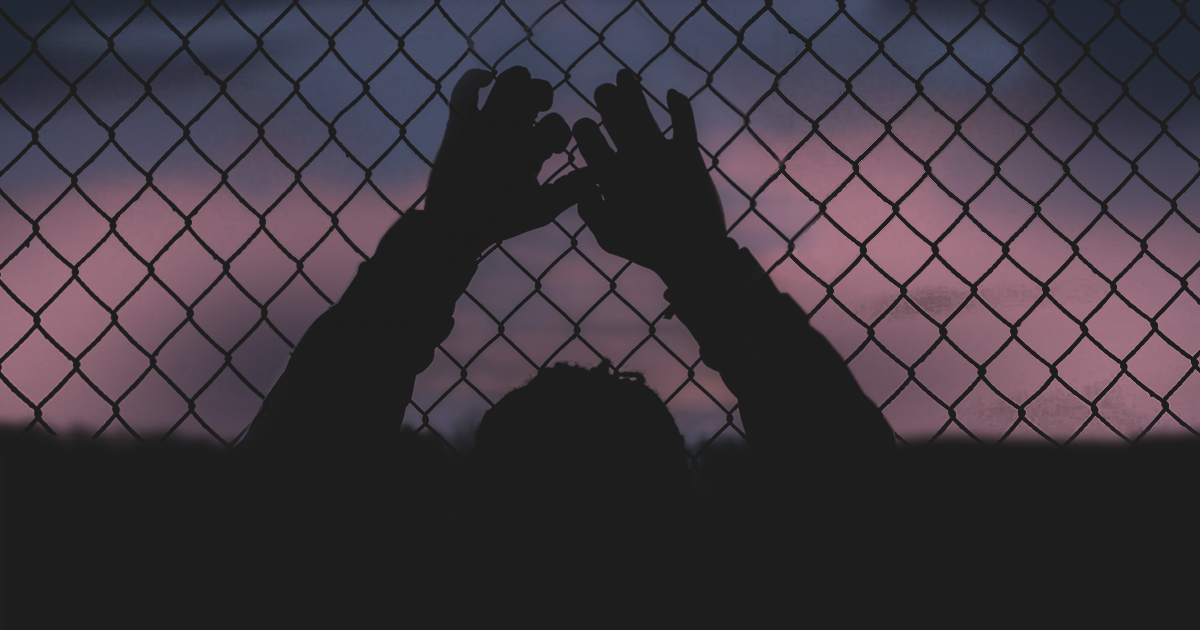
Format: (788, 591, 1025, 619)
(0, 424, 1200, 629)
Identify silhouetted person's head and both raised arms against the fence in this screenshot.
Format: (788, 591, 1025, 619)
(231, 67, 893, 508)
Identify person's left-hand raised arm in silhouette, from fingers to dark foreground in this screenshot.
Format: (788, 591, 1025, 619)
(231, 66, 584, 451)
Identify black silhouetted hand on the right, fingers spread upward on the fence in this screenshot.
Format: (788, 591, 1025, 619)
(575, 70, 726, 280)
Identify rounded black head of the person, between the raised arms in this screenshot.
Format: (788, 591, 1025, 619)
(472, 360, 690, 510)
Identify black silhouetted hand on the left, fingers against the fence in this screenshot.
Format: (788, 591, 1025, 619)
(425, 66, 586, 250)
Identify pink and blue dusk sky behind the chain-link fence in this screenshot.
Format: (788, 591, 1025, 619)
(0, 0, 1200, 448)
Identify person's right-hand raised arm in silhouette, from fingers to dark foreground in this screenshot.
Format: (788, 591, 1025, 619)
(575, 70, 893, 466)
